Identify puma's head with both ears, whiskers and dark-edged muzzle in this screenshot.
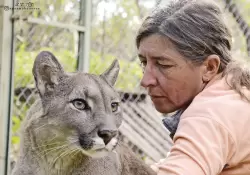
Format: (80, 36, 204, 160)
(31, 51, 122, 155)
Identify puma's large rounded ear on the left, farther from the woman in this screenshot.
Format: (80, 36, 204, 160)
(33, 51, 64, 96)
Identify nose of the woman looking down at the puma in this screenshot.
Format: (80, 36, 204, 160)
(141, 66, 157, 88)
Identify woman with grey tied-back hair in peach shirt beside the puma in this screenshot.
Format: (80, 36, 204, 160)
(136, 0, 250, 175)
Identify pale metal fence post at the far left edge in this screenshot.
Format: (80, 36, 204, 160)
(0, 0, 13, 175)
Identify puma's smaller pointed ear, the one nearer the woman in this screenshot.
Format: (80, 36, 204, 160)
(101, 59, 120, 86)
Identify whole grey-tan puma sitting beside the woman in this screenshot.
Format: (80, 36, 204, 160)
(12, 52, 156, 175)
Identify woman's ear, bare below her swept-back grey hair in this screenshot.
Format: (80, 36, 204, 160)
(202, 55, 220, 82)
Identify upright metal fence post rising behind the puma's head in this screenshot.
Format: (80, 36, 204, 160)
(77, 0, 92, 72)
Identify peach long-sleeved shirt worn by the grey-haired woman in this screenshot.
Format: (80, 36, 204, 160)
(157, 74, 250, 175)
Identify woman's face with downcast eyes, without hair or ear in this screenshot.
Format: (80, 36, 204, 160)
(138, 34, 205, 113)
